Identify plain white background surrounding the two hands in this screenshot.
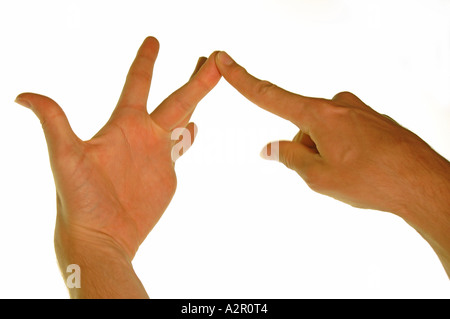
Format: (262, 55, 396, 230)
(0, 0, 450, 298)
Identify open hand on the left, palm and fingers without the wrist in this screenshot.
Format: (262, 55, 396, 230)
(19, 38, 220, 258)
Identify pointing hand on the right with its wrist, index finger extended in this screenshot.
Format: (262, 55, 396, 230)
(216, 52, 450, 276)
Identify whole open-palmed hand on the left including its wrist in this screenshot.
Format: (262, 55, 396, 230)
(16, 37, 221, 298)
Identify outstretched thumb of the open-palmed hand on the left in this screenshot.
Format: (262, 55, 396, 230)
(15, 93, 78, 153)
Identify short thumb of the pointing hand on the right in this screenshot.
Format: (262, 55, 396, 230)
(261, 141, 318, 178)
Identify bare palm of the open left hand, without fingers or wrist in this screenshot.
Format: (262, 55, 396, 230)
(54, 110, 176, 258)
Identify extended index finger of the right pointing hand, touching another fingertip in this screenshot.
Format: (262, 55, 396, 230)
(216, 51, 312, 124)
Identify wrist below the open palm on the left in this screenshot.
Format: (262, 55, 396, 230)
(55, 218, 148, 298)
